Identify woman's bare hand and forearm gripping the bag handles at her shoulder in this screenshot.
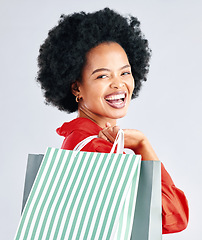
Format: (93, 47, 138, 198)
(98, 122, 158, 160)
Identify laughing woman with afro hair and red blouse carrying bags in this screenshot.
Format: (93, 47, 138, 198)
(37, 8, 188, 233)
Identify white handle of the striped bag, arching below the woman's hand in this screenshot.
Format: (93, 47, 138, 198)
(73, 129, 124, 153)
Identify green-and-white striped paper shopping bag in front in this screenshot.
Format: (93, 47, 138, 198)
(15, 130, 141, 239)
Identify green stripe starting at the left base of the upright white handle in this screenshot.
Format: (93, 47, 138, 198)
(83, 153, 115, 239)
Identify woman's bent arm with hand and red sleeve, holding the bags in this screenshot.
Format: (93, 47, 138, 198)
(99, 124, 189, 234)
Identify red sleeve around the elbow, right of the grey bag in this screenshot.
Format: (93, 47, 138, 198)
(161, 164, 189, 234)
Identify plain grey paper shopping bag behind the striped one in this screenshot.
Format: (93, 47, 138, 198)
(22, 154, 162, 240)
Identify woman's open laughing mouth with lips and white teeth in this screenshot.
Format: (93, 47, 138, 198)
(105, 91, 126, 108)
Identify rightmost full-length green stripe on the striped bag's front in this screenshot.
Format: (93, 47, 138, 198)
(107, 157, 134, 239)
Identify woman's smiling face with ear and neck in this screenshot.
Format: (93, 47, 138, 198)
(72, 42, 134, 127)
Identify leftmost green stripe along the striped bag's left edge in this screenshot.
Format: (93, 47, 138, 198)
(15, 148, 51, 240)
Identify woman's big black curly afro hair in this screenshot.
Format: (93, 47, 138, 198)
(37, 8, 151, 113)
